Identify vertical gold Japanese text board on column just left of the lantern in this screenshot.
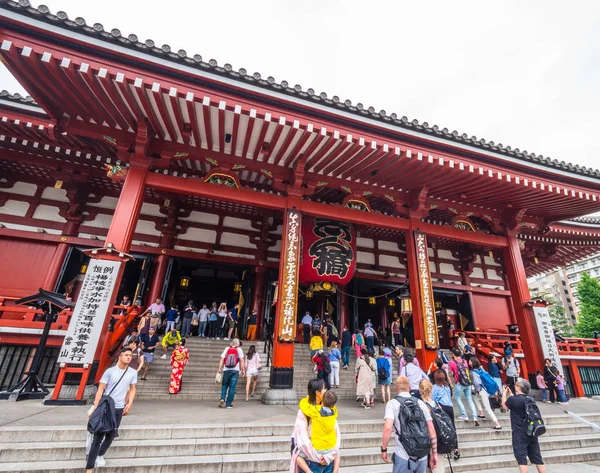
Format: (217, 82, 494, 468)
(278, 210, 301, 341)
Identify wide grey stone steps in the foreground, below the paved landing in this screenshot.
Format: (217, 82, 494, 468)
(0, 408, 600, 473)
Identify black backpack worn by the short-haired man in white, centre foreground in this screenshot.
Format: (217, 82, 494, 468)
(396, 396, 431, 462)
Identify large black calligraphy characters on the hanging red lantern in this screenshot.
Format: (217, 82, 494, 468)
(308, 218, 354, 279)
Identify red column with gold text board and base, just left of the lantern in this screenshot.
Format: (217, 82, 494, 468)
(263, 209, 302, 404)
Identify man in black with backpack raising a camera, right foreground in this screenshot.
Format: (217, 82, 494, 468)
(502, 378, 546, 473)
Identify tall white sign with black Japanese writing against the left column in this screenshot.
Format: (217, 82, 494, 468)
(58, 259, 121, 365)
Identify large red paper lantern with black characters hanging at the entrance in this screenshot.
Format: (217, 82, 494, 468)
(300, 217, 356, 285)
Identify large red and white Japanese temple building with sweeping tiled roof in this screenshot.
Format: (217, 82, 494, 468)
(0, 1, 600, 396)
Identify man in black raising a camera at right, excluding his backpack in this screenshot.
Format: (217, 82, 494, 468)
(502, 378, 546, 473)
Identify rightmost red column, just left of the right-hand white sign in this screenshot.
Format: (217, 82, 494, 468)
(503, 235, 544, 377)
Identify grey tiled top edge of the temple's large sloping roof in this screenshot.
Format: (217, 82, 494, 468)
(0, 0, 600, 183)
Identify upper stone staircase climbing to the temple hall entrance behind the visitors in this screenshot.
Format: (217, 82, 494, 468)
(137, 337, 368, 402)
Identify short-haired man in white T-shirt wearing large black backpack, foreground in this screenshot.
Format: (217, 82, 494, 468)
(381, 376, 437, 473)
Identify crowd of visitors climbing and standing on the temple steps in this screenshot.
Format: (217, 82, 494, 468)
(86, 300, 567, 473)
